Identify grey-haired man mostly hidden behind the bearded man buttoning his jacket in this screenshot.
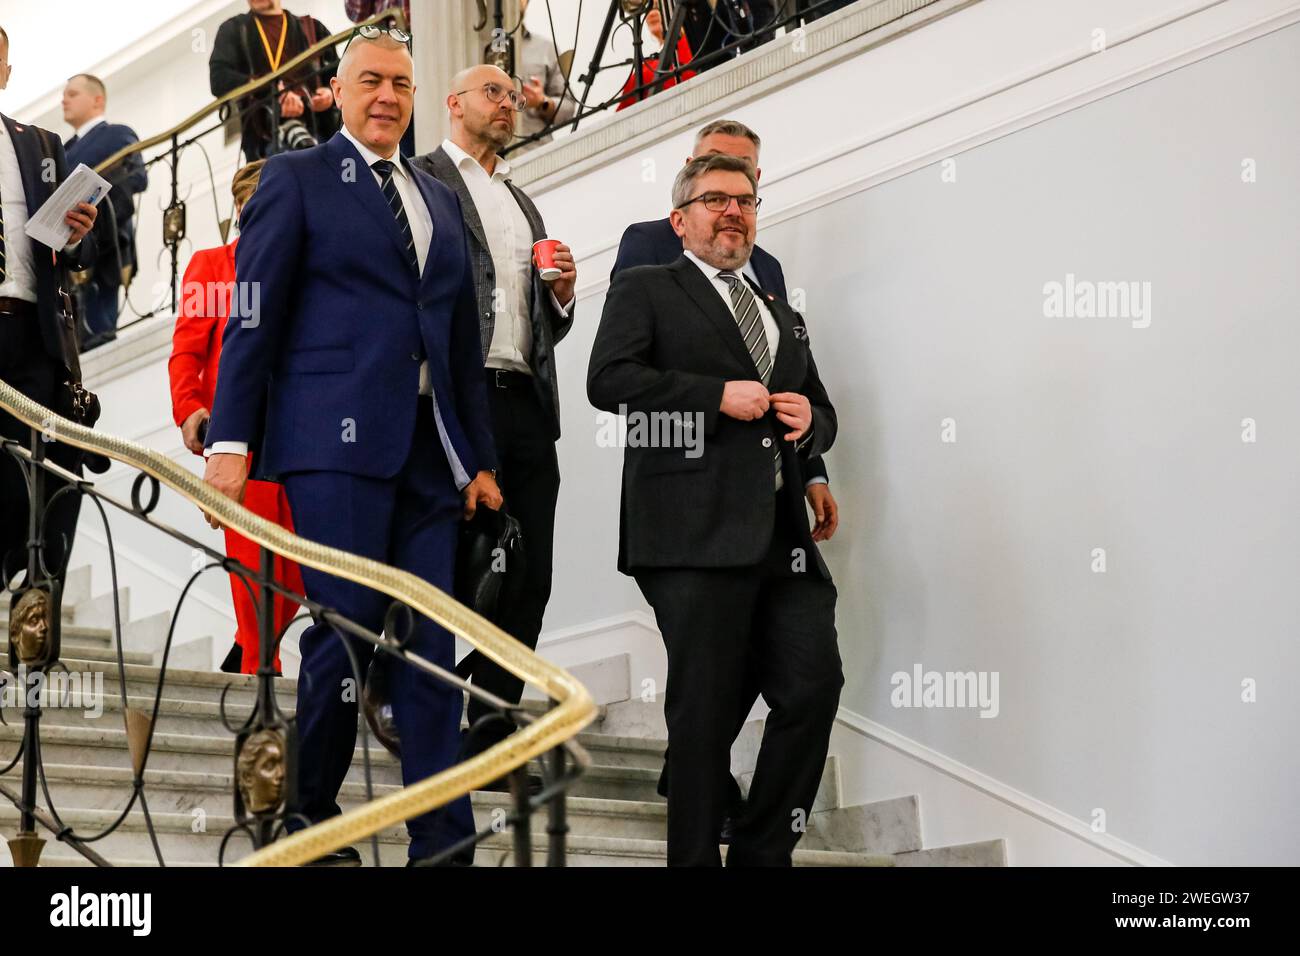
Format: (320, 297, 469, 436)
(610, 120, 840, 843)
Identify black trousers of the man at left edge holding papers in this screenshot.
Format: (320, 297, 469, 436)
(0, 313, 81, 595)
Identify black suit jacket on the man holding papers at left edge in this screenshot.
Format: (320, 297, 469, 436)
(0, 113, 96, 364)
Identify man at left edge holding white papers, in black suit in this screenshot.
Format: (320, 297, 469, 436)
(0, 27, 95, 589)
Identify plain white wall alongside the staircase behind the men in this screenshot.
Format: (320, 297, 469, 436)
(35, 0, 1300, 864)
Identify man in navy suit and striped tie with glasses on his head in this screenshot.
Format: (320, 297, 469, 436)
(205, 33, 502, 865)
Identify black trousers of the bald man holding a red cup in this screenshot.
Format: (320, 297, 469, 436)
(460, 369, 560, 752)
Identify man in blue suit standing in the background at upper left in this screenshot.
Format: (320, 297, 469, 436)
(64, 73, 150, 351)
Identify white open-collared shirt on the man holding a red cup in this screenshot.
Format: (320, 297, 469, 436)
(442, 139, 572, 375)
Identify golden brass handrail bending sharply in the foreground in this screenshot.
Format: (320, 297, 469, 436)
(0, 381, 595, 866)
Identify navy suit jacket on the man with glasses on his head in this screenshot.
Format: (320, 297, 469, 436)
(208, 133, 497, 484)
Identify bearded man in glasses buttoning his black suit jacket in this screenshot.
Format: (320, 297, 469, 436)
(588, 155, 844, 866)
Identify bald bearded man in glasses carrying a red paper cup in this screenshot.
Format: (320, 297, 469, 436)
(412, 64, 577, 786)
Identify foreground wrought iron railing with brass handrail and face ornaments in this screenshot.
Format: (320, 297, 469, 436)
(0, 381, 595, 866)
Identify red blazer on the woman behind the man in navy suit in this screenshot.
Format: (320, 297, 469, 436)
(166, 239, 239, 425)
